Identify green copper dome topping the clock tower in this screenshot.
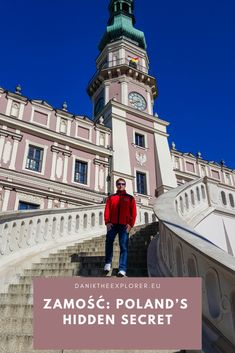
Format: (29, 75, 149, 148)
(98, 0, 147, 51)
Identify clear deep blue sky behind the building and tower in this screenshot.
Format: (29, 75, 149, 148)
(0, 0, 235, 168)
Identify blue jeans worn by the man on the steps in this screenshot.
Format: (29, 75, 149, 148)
(105, 224, 129, 272)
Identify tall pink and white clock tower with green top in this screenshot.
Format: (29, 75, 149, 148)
(87, 0, 176, 202)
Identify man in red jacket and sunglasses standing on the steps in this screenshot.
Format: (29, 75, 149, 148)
(104, 178, 136, 277)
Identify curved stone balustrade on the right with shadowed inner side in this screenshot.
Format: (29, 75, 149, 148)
(151, 178, 235, 353)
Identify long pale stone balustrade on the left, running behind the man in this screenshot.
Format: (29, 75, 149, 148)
(0, 204, 155, 289)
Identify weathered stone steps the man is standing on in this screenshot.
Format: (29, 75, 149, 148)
(0, 222, 182, 353)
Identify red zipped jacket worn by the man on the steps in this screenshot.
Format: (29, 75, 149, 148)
(104, 190, 136, 227)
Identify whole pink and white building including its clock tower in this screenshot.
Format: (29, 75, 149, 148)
(0, 0, 235, 212)
